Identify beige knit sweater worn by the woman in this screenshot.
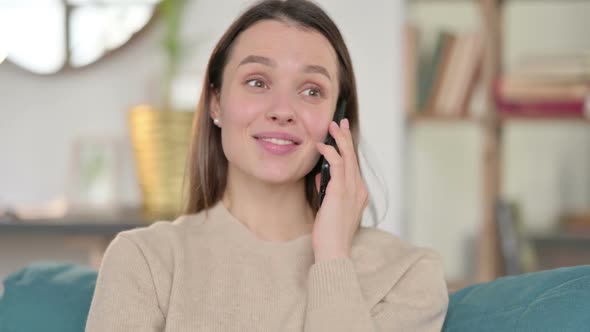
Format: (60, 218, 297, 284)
(86, 202, 448, 332)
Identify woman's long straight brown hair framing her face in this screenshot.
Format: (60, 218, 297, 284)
(183, 0, 359, 214)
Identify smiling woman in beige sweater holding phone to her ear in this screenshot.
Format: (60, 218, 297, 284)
(86, 0, 448, 332)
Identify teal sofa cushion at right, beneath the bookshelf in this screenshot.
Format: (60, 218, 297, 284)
(443, 265, 590, 332)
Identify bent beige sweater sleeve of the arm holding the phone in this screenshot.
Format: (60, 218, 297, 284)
(304, 255, 448, 332)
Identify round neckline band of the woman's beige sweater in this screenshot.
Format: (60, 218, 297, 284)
(209, 200, 312, 249)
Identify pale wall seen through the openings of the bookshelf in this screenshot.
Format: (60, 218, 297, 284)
(407, 1, 590, 280)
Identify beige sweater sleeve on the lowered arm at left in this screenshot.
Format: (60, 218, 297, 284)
(86, 234, 165, 332)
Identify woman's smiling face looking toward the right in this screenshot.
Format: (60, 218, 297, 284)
(211, 20, 339, 184)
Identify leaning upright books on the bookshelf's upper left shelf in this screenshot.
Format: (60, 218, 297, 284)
(416, 27, 484, 116)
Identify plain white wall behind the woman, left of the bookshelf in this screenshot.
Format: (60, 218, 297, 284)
(0, 0, 402, 278)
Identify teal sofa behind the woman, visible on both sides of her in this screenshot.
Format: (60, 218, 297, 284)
(0, 262, 590, 332)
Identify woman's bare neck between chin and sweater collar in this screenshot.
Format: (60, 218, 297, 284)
(223, 165, 315, 241)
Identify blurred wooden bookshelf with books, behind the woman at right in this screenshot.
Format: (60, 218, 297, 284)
(404, 0, 590, 288)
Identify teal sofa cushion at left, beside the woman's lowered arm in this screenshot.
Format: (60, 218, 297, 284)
(0, 262, 97, 332)
